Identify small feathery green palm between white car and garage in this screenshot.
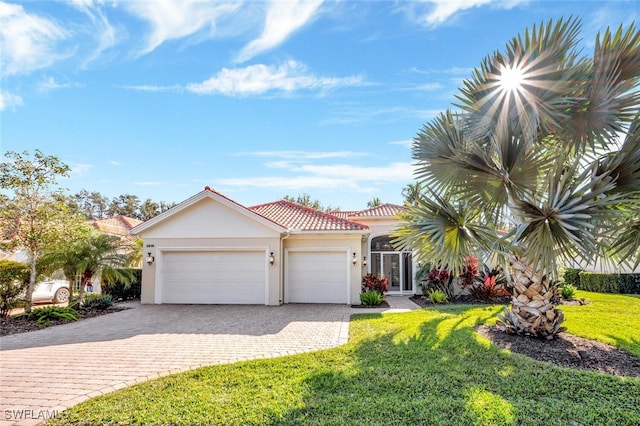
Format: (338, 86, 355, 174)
(43, 233, 137, 300)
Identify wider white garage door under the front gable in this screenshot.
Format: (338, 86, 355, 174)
(160, 251, 267, 304)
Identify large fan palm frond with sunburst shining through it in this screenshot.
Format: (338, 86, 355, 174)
(456, 18, 582, 140)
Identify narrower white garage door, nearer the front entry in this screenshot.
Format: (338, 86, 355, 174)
(285, 250, 349, 303)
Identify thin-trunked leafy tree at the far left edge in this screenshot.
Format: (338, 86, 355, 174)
(0, 150, 82, 312)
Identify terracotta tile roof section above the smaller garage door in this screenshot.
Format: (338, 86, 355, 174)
(249, 200, 369, 231)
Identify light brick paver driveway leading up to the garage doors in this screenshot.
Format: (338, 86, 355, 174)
(0, 298, 417, 425)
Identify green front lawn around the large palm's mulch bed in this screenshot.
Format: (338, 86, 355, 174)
(53, 293, 640, 425)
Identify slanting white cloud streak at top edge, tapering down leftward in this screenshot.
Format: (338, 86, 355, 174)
(236, 0, 323, 62)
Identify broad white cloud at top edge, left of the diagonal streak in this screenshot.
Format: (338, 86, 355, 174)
(122, 0, 241, 55)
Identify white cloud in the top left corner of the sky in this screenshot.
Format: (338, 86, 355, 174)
(0, 2, 69, 76)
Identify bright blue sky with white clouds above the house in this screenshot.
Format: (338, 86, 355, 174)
(0, 0, 640, 210)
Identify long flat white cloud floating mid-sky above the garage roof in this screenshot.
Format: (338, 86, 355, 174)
(186, 60, 365, 96)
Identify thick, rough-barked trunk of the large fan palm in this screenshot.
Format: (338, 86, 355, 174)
(496, 258, 566, 340)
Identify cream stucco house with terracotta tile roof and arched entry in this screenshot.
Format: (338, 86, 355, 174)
(131, 187, 416, 305)
